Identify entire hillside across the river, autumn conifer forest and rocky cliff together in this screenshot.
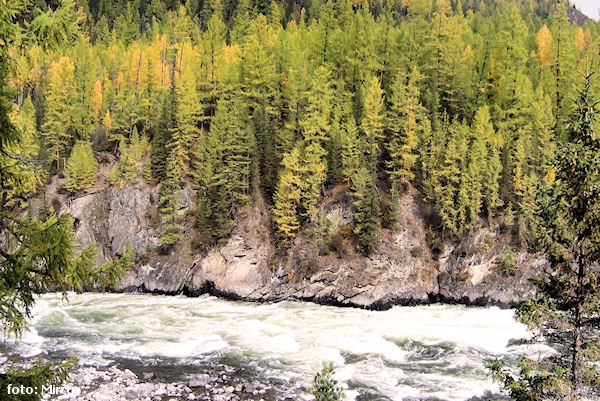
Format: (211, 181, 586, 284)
(3, 0, 600, 308)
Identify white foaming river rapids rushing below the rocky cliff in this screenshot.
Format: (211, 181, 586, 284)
(5, 294, 548, 400)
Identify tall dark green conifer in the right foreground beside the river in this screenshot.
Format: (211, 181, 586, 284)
(488, 74, 600, 401)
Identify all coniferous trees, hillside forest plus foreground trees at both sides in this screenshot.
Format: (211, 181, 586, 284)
(0, 0, 600, 400)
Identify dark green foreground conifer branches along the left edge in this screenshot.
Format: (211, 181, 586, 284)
(0, 0, 131, 400)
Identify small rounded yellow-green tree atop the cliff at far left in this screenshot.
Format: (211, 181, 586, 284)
(65, 141, 98, 192)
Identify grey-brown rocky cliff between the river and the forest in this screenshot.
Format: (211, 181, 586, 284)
(46, 173, 545, 309)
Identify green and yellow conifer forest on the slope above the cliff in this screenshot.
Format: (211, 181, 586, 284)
(4, 0, 600, 304)
